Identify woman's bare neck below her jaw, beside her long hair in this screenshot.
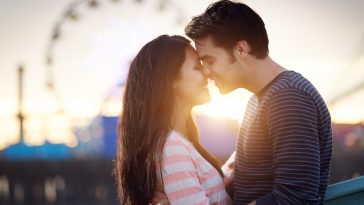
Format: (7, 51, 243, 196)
(172, 102, 192, 137)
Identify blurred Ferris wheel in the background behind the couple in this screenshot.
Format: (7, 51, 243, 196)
(45, 0, 187, 126)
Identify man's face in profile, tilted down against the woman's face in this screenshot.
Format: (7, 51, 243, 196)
(195, 37, 241, 94)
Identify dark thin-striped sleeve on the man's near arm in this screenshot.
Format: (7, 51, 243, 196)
(256, 89, 320, 205)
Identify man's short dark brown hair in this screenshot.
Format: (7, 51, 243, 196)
(185, 0, 269, 59)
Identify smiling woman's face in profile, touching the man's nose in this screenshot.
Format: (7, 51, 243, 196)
(173, 46, 210, 106)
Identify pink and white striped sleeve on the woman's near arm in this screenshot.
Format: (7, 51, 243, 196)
(161, 141, 210, 205)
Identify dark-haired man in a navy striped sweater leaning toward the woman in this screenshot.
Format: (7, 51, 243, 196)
(185, 0, 332, 205)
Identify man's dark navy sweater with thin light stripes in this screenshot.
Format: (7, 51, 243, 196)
(234, 71, 332, 205)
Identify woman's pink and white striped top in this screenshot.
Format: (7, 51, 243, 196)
(153, 131, 229, 205)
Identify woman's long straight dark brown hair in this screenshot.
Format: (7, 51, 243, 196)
(115, 35, 222, 205)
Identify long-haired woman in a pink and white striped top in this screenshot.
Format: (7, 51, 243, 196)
(115, 35, 232, 205)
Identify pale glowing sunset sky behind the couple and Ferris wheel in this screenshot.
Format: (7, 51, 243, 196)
(0, 0, 364, 149)
